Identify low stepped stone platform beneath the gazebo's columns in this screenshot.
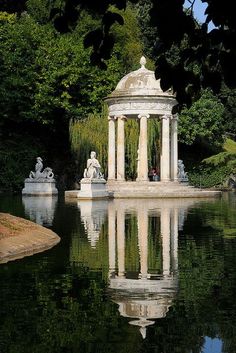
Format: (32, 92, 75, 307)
(107, 181, 222, 198)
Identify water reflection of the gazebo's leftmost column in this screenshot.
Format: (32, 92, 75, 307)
(108, 203, 116, 276)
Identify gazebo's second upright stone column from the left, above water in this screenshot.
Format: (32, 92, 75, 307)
(117, 116, 126, 181)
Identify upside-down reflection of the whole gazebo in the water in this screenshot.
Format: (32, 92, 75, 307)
(108, 200, 180, 338)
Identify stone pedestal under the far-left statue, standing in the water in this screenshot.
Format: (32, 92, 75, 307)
(22, 178, 58, 196)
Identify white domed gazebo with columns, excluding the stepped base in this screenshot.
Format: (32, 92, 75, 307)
(105, 57, 178, 182)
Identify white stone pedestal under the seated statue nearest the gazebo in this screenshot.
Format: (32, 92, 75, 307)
(77, 178, 109, 199)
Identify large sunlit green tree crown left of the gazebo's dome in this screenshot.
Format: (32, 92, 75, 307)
(0, 15, 119, 124)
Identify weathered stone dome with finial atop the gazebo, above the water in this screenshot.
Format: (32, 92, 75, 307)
(109, 56, 174, 97)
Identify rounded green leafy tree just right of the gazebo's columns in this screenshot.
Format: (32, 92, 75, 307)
(178, 90, 224, 147)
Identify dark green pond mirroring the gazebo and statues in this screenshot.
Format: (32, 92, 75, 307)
(0, 192, 236, 353)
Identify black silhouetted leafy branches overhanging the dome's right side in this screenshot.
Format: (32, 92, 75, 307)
(151, 0, 236, 104)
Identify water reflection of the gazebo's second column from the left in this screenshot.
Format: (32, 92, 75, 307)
(117, 209, 125, 277)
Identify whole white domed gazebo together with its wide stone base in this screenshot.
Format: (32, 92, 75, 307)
(65, 57, 221, 199)
